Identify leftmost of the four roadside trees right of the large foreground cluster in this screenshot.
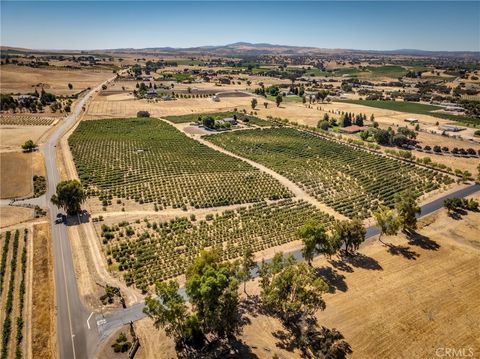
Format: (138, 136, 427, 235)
(298, 220, 337, 266)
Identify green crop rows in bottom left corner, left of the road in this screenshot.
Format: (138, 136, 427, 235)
(0, 229, 28, 359)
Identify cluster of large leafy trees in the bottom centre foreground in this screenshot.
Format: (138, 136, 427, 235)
(144, 250, 351, 358)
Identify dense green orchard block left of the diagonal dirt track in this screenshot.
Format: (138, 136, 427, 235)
(69, 119, 291, 210)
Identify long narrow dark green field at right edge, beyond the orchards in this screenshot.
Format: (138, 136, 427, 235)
(337, 100, 480, 125)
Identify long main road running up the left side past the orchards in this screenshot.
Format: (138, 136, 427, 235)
(40, 80, 116, 359)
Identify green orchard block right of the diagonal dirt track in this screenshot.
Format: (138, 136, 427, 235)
(207, 128, 453, 218)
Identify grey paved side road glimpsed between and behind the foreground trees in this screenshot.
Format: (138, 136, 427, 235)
(96, 184, 480, 340)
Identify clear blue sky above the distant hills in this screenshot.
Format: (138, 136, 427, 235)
(1, 0, 480, 51)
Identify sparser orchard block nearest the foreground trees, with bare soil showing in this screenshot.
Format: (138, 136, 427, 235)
(102, 199, 334, 291)
